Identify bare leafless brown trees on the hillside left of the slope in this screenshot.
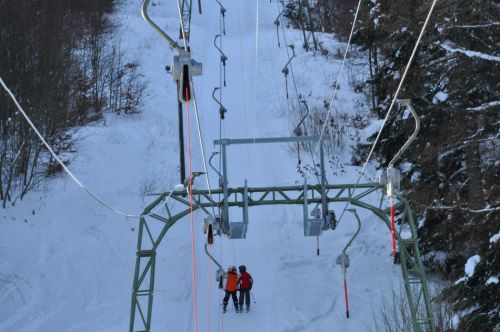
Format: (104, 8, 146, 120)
(0, 0, 144, 208)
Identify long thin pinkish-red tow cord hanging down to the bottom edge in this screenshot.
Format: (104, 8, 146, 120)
(185, 87, 198, 332)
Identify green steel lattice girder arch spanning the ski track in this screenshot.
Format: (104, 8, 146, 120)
(129, 183, 436, 332)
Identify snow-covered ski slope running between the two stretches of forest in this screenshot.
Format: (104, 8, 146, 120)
(0, 0, 401, 332)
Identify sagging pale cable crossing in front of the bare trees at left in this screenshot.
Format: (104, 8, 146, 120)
(0, 77, 152, 219)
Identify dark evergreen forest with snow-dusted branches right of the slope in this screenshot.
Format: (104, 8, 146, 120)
(285, 0, 500, 331)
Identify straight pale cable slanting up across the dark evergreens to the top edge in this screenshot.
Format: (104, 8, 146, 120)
(337, 0, 437, 228)
